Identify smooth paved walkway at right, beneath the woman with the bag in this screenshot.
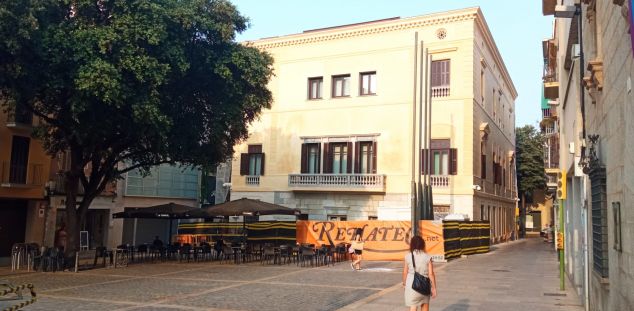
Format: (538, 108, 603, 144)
(340, 238, 583, 311)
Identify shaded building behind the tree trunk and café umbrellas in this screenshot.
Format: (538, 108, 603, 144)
(45, 161, 201, 249)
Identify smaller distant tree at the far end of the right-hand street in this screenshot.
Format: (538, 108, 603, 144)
(515, 125, 546, 237)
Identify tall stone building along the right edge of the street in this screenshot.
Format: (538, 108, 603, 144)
(542, 0, 634, 310)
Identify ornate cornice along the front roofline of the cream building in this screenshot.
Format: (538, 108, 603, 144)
(245, 9, 478, 50)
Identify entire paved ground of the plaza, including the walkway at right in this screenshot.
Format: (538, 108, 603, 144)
(0, 239, 581, 311)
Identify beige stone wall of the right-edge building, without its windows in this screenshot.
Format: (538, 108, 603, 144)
(555, 0, 634, 310)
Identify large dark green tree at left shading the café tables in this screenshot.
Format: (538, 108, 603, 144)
(0, 0, 273, 253)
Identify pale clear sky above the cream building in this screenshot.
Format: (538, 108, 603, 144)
(232, 0, 553, 126)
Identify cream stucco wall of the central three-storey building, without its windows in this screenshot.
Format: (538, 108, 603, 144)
(232, 8, 517, 232)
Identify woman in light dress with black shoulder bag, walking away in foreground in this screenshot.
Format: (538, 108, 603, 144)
(403, 236, 436, 311)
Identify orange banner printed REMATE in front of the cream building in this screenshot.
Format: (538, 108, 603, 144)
(297, 220, 445, 261)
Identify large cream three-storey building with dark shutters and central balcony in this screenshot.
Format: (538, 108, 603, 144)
(231, 8, 517, 241)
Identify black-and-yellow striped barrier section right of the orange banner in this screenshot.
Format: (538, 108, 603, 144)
(443, 221, 491, 259)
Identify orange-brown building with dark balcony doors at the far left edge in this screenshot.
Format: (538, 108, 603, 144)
(0, 107, 50, 259)
